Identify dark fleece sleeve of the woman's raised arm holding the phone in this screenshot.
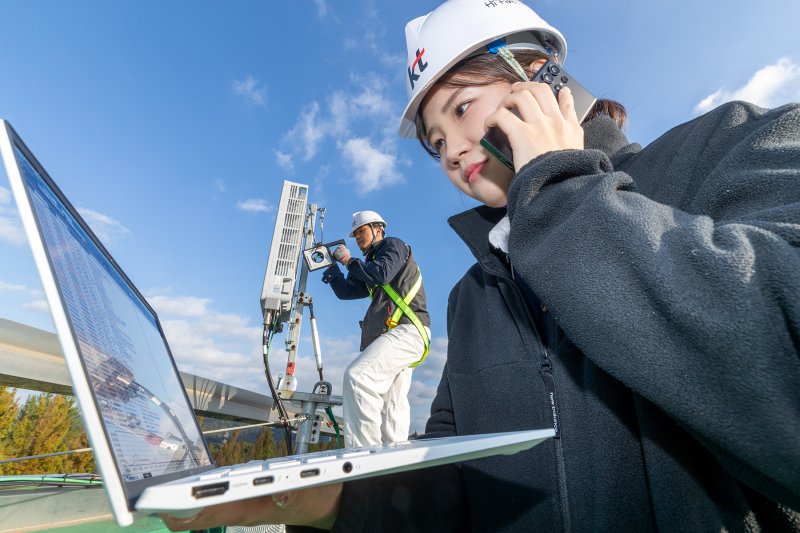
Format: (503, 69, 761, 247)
(508, 104, 800, 508)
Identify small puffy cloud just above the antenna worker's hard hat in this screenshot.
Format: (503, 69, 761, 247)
(339, 137, 403, 194)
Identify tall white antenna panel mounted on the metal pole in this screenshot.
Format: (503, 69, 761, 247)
(261, 181, 308, 322)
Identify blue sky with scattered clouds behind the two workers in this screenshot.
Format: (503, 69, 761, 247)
(0, 0, 800, 431)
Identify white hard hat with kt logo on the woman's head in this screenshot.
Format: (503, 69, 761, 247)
(400, 0, 567, 138)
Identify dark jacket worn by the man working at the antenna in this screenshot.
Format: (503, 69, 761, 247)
(322, 237, 431, 351)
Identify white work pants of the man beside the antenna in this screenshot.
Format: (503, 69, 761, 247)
(342, 324, 430, 448)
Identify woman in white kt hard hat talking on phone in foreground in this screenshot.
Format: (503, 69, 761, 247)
(162, 0, 800, 532)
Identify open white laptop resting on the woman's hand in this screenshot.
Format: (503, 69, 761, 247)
(0, 120, 553, 526)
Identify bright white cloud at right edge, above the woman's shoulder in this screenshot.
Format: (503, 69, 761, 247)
(694, 57, 800, 115)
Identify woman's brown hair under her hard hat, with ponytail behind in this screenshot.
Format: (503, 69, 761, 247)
(415, 49, 628, 159)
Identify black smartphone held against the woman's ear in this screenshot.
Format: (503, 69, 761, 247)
(481, 60, 597, 169)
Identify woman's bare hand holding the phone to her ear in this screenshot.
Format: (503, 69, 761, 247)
(485, 82, 583, 172)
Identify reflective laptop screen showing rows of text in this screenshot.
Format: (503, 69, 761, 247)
(9, 140, 212, 490)
